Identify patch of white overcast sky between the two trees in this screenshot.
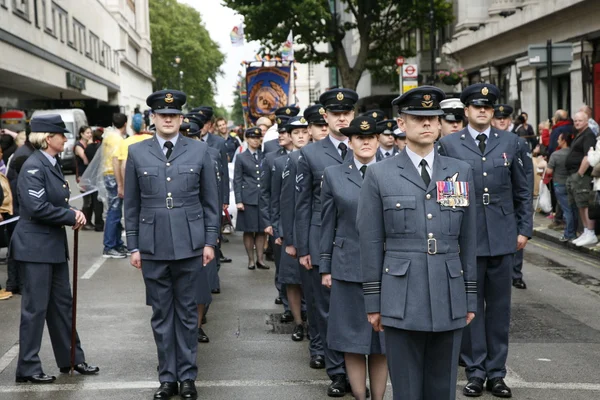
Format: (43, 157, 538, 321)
(179, 0, 260, 108)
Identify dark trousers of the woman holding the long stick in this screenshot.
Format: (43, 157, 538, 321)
(17, 261, 85, 376)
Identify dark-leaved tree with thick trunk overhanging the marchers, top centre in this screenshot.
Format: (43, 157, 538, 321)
(223, 0, 453, 89)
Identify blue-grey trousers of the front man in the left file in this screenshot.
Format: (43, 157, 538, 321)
(142, 257, 202, 382)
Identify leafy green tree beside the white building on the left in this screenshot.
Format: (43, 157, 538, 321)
(149, 0, 225, 108)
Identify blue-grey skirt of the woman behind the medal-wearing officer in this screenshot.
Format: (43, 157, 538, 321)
(327, 279, 385, 354)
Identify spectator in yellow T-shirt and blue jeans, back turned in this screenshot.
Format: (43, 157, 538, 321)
(102, 113, 127, 258)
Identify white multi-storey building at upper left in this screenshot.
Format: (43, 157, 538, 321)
(0, 0, 152, 125)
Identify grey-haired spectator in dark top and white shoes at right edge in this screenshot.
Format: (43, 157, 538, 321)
(566, 111, 598, 246)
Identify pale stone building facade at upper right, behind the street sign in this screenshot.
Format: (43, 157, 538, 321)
(442, 0, 600, 122)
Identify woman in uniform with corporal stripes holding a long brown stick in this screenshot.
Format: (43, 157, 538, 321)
(10, 115, 99, 383)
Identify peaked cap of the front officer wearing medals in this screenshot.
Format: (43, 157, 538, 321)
(392, 86, 446, 116)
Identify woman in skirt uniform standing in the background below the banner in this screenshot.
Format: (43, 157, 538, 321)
(233, 128, 269, 269)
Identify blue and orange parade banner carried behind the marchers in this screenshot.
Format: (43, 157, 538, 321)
(244, 63, 292, 124)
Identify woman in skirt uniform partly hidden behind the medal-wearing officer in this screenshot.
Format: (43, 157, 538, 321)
(319, 117, 386, 400)
